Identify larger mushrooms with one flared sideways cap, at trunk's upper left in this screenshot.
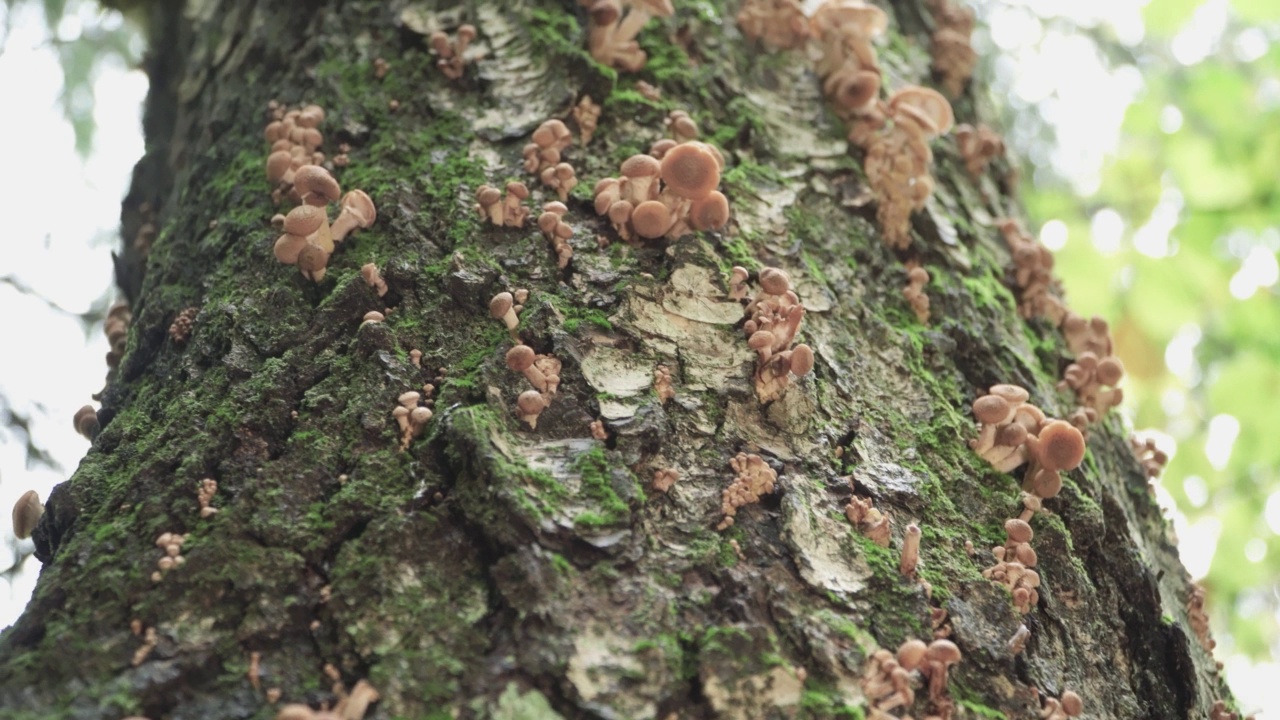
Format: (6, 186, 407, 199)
(268, 165, 378, 282)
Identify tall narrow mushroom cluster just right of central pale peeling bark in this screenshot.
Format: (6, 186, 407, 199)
(742, 268, 814, 402)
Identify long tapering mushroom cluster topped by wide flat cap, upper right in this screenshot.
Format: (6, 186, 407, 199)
(864, 86, 955, 250)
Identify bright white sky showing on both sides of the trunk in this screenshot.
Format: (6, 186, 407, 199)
(0, 0, 1280, 720)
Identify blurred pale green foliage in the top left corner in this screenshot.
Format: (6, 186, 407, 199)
(0, 0, 142, 155)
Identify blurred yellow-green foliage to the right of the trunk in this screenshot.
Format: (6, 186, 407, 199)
(988, 0, 1280, 657)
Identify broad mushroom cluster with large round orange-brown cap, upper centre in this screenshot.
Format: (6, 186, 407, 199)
(595, 140, 728, 241)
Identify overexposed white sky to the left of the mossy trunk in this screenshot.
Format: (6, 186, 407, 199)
(0, 3, 147, 626)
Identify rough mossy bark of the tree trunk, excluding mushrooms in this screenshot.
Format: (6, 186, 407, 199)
(0, 0, 1226, 720)
